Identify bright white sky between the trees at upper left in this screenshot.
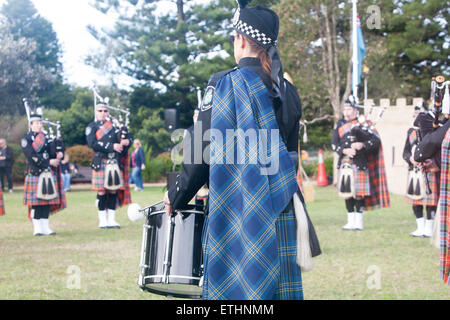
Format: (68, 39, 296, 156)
(0, 0, 173, 87)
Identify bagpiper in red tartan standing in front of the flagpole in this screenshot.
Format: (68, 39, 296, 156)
(332, 97, 390, 230)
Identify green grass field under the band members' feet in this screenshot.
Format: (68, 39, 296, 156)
(0, 187, 450, 300)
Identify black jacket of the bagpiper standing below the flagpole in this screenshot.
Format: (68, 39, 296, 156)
(333, 120, 381, 170)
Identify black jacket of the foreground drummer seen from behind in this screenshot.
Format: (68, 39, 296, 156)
(168, 58, 301, 210)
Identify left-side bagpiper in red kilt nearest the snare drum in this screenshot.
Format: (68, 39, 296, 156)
(86, 102, 132, 229)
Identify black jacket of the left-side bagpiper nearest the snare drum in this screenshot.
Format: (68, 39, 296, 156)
(86, 121, 133, 171)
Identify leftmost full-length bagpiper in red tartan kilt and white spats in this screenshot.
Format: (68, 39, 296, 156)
(21, 114, 66, 236)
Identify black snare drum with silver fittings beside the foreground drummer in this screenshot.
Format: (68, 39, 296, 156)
(138, 206, 205, 299)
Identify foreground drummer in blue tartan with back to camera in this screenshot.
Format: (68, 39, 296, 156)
(164, 4, 303, 300)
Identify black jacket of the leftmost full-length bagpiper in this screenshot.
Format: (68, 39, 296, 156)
(21, 131, 64, 176)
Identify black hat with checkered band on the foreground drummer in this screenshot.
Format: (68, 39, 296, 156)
(233, 0, 280, 49)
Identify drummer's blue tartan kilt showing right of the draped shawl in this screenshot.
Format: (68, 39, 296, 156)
(273, 211, 303, 300)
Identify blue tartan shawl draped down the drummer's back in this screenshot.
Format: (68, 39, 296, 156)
(203, 68, 298, 300)
